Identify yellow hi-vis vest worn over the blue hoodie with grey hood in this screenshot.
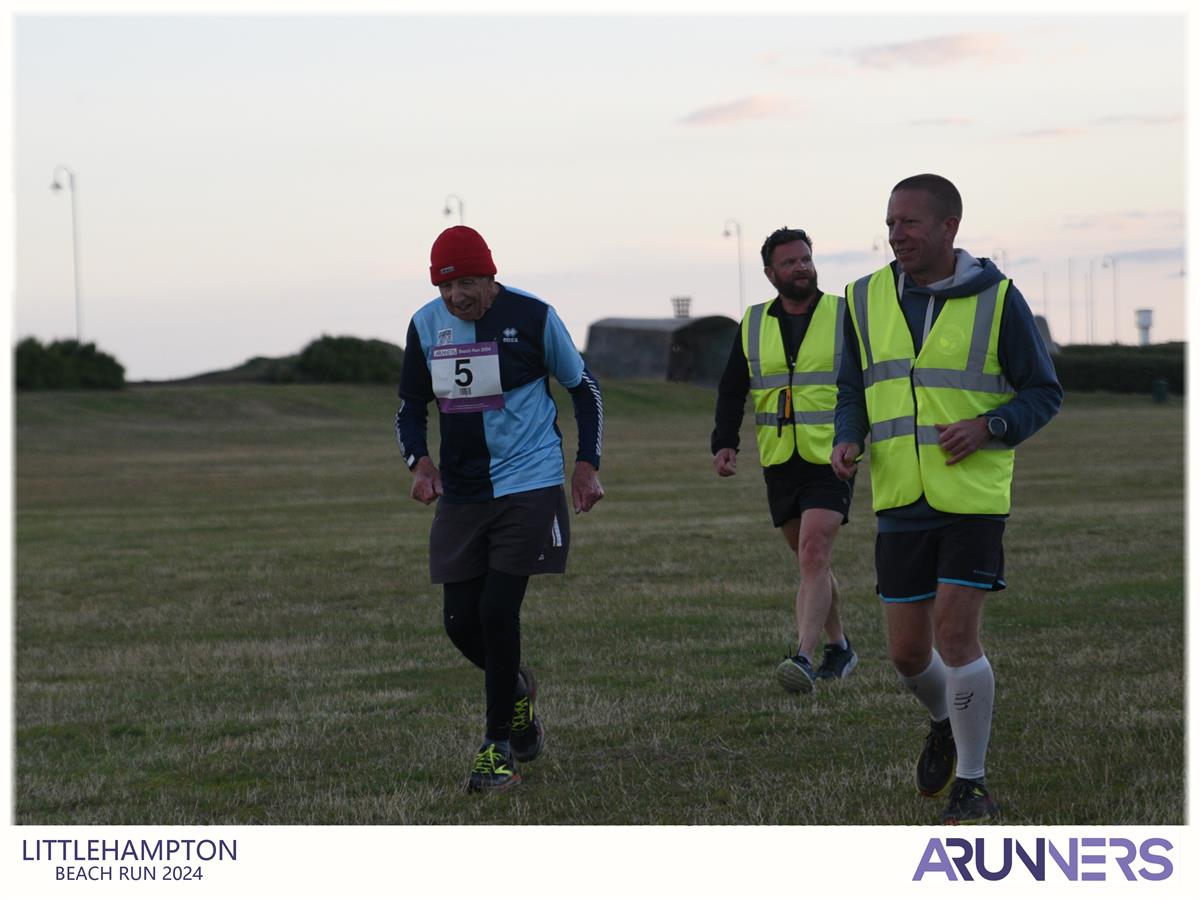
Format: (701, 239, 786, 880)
(846, 266, 1015, 515)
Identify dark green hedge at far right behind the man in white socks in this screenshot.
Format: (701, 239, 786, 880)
(1054, 342, 1187, 394)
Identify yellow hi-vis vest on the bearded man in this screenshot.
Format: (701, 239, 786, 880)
(742, 294, 846, 466)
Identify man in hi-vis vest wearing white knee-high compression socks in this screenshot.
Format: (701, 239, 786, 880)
(830, 174, 1062, 824)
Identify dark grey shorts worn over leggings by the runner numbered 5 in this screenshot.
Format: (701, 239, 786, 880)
(430, 485, 571, 584)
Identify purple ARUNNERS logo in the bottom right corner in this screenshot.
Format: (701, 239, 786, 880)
(912, 838, 1175, 881)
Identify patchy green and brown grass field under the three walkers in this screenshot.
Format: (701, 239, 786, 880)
(16, 383, 1184, 824)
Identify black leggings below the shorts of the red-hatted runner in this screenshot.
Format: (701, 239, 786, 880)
(442, 569, 529, 740)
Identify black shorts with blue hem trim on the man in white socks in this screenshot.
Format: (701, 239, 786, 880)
(875, 516, 1004, 604)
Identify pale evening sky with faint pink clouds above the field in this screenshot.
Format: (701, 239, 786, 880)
(12, 7, 1186, 380)
